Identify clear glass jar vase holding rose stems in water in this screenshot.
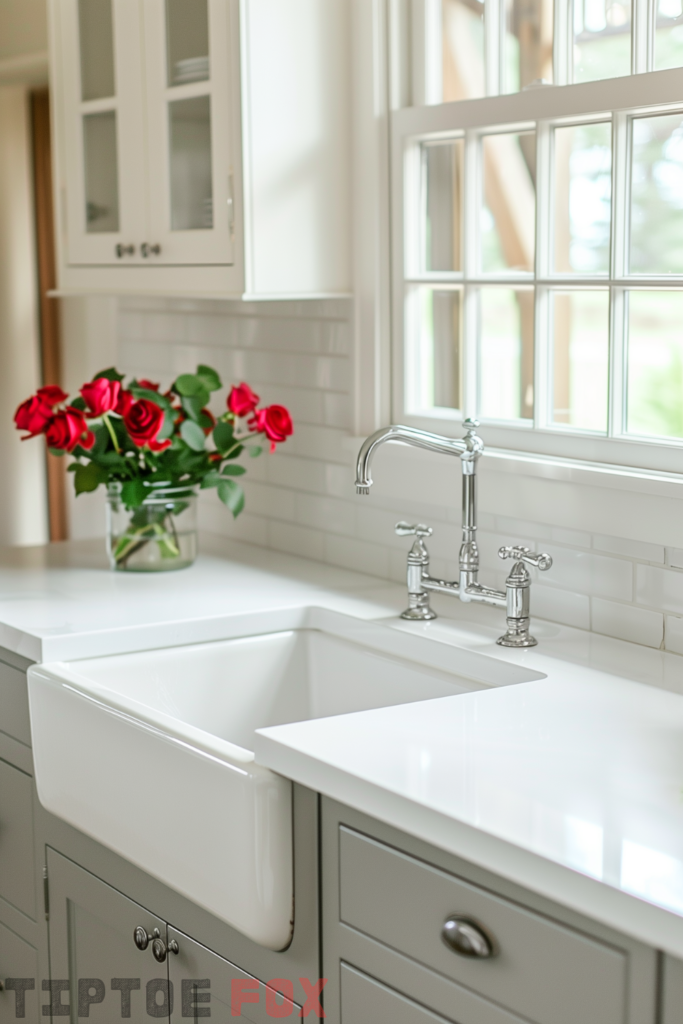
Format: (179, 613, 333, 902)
(106, 482, 197, 572)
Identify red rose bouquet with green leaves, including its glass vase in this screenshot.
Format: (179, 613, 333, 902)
(14, 366, 293, 569)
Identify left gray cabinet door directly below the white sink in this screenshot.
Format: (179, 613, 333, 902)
(43, 850, 170, 1024)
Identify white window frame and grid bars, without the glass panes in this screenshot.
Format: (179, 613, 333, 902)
(391, 0, 683, 473)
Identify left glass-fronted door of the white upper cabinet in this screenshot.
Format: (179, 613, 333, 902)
(56, 0, 146, 264)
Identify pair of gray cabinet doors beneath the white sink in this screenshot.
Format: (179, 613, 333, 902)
(46, 850, 300, 1024)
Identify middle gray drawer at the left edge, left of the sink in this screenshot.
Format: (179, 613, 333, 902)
(0, 761, 36, 921)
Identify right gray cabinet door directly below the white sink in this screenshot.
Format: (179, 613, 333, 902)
(168, 927, 301, 1024)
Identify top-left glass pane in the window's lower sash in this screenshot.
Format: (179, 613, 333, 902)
(422, 139, 465, 270)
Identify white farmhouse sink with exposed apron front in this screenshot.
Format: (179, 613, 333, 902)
(29, 613, 539, 949)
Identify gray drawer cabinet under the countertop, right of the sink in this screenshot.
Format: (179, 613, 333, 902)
(322, 800, 659, 1024)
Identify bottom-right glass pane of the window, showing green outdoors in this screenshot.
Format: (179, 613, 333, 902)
(627, 291, 683, 437)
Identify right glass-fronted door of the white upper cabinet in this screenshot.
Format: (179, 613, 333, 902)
(143, 0, 238, 264)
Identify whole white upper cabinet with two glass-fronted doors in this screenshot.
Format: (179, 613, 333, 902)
(50, 0, 350, 298)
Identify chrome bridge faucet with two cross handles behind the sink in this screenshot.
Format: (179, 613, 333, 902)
(355, 420, 553, 647)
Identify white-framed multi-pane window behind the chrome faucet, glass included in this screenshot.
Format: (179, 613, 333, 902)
(392, 0, 683, 472)
